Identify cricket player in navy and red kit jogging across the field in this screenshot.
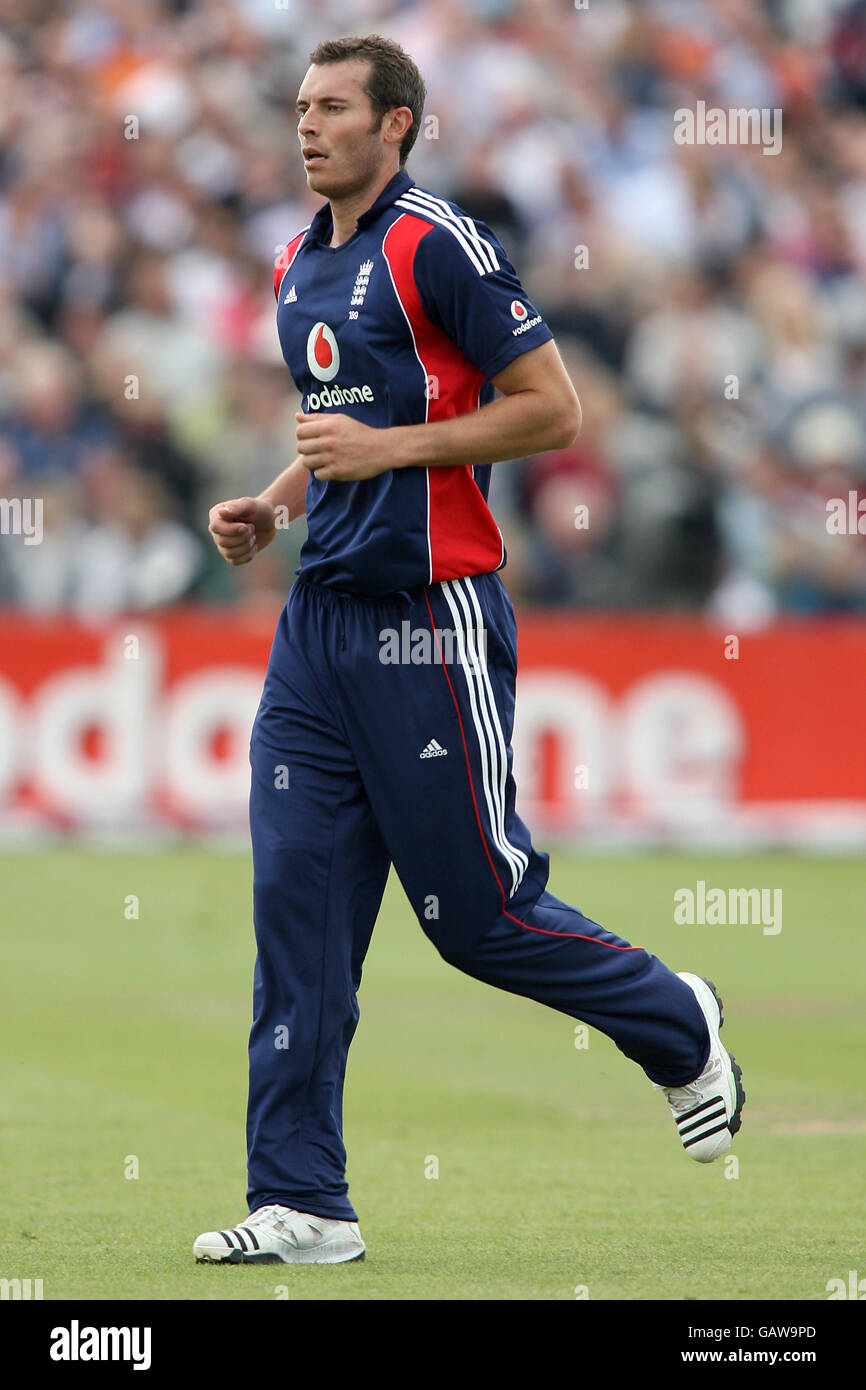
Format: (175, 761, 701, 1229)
(193, 35, 745, 1264)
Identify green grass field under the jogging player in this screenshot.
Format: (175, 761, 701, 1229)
(0, 847, 866, 1300)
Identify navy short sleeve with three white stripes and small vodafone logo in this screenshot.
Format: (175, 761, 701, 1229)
(413, 214, 553, 381)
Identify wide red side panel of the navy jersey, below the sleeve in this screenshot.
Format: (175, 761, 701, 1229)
(382, 214, 503, 584)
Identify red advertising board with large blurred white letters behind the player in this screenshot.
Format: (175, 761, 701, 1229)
(0, 607, 866, 845)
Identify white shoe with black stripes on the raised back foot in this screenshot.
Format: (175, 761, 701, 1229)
(653, 970, 745, 1163)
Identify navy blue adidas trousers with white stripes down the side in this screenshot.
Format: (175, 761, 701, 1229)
(247, 574, 709, 1220)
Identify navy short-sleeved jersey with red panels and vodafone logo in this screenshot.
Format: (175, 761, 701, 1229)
(274, 171, 553, 598)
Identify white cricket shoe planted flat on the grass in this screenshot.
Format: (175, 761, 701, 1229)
(192, 1205, 366, 1265)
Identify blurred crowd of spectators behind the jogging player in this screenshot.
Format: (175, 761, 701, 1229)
(0, 0, 866, 627)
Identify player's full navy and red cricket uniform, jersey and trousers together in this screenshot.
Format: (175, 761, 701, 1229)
(247, 171, 709, 1220)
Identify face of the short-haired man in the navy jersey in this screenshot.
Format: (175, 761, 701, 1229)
(297, 61, 396, 199)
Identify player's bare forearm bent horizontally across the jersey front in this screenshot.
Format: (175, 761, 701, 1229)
(388, 391, 580, 468)
